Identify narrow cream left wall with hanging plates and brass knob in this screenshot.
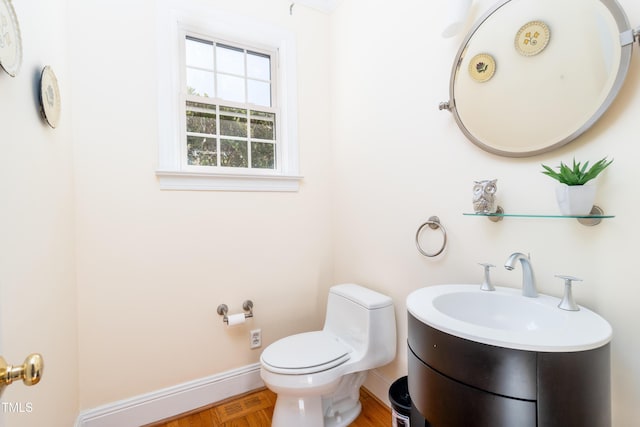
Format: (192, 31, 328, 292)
(0, 0, 78, 427)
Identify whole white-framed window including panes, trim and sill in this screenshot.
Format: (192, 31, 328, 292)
(156, 0, 301, 191)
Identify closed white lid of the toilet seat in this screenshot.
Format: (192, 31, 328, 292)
(260, 331, 351, 374)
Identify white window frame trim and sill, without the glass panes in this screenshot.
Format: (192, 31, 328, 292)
(156, 0, 302, 191)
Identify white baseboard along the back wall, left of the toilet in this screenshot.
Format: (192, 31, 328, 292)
(75, 363, 264, 427)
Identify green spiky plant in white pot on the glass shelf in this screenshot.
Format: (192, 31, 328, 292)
(542, 157, 613, 216)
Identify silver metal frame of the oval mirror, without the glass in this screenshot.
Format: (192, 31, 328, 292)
(440, 0, 634, 157)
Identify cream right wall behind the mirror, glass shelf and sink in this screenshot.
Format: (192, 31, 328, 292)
(331, 0, 640, 427)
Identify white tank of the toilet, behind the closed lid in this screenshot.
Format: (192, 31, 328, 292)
(323, 283, 396, 369)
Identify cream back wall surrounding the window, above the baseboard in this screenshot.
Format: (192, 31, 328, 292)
(70, 0, 332, 409)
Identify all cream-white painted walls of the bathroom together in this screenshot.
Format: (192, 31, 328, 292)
(0, 0, 640, 427)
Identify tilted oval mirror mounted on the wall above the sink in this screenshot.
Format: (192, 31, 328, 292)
(448, 0, 633, 157)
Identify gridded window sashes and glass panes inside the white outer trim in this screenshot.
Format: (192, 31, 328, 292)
(183, 35, 279, 170)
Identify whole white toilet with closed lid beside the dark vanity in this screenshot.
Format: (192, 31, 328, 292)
(260, 284, 396, 427)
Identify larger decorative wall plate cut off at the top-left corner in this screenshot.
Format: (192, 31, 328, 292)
(0, 0, 22, 77)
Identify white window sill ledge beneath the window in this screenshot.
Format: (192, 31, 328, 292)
(156, 170, 302, 192)
